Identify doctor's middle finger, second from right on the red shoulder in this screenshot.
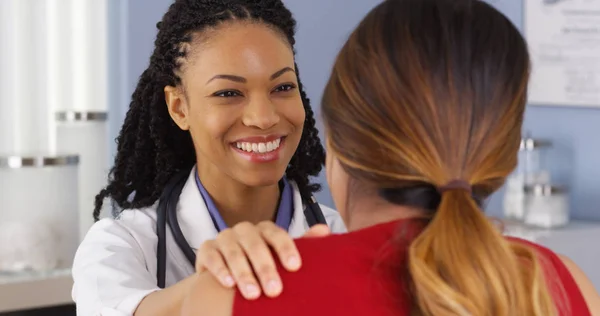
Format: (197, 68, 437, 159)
(232, 223, 289, 297)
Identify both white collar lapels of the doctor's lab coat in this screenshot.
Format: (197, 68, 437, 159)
(177, 168, 308, 251)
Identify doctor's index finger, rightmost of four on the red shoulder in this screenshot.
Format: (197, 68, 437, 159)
(257, 222, 302, 271)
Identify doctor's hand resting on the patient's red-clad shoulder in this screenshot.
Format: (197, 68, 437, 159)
(196, 221, 330, 299)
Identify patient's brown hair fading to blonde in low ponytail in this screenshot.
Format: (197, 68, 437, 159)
(323, 0, 556, 316)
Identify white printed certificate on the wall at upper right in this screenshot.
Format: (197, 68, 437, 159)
(523, 0, 600, 108)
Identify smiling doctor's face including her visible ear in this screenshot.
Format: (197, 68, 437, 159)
(165, 22, 305, 186)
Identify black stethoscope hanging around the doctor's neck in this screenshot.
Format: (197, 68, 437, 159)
(156, 170, 327, 289)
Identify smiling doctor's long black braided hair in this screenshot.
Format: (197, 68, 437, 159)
(93, 0, 325, 220)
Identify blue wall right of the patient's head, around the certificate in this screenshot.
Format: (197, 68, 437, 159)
(487, 0, 600, 220)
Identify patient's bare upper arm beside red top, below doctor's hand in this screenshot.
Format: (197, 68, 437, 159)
(181, 271, 236, 316)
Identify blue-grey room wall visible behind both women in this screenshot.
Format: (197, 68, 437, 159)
(122, 0, 600, 220)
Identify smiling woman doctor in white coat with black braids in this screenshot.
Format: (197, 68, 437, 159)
(73, 0, 345, 315)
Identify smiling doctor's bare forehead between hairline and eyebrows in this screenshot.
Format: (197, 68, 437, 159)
(177, 21, 294, 80)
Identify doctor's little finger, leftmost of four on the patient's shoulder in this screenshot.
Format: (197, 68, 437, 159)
(196, 240, 235, 287)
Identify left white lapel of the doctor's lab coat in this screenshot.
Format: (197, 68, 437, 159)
(177, 168, 218, 251)
